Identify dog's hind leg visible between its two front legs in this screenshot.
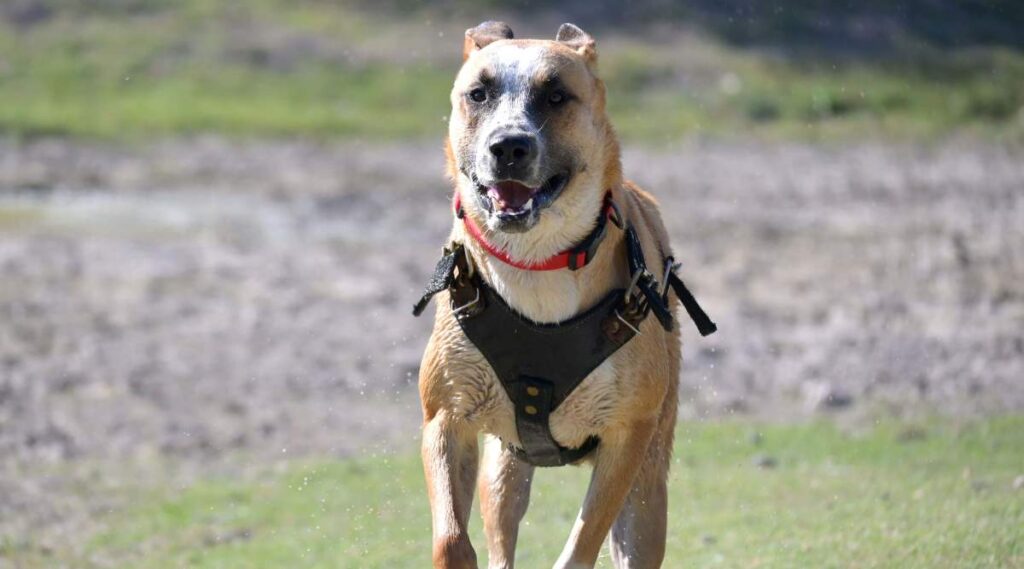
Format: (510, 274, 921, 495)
(477, 436, 534, 569)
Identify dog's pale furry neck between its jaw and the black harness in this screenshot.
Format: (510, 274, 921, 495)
(453, 180, 627, 322)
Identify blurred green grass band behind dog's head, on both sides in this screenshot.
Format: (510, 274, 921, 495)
(0, 0, 1024, 142)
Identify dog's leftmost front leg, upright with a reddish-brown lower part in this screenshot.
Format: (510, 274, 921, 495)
(422, 411, 477, 569)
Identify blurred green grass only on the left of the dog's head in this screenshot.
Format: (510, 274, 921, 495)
(0, 2, 450, 138)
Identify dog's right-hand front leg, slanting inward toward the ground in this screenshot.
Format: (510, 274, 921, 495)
(555, 418, 656, 569)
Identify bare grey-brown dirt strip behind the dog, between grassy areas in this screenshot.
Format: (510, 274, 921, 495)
(0, 138, 1024, 541)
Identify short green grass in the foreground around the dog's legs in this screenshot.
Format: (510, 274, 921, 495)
(0, 417, 1024, 569)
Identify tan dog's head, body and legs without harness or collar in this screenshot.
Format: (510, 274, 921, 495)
(420, 23, 696, 568)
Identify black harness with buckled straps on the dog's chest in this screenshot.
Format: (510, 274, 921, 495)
(413, 202, 717, 467)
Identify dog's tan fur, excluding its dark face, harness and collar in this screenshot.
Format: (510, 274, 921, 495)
(420, 23, 680, 568)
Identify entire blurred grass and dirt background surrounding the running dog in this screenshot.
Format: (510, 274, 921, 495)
(0, 0, 1024, 568)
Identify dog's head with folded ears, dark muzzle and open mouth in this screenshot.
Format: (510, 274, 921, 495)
(449, 21, 617, 233)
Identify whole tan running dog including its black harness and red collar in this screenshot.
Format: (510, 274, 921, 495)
(416, 21, 714, 568)
